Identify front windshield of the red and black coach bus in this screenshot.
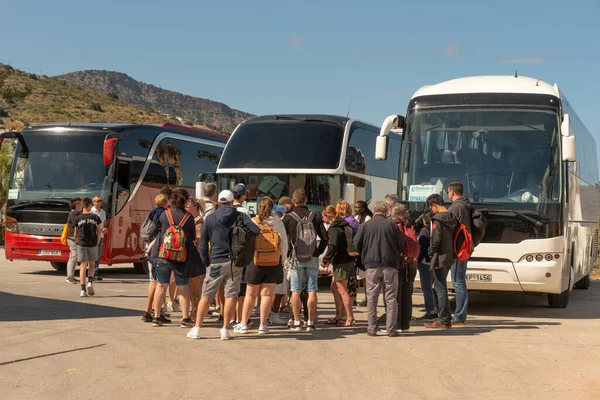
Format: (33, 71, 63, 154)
(8, 131, 106, 207)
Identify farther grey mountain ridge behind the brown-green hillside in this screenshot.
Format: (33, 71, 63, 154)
(56, 70, 252, 133)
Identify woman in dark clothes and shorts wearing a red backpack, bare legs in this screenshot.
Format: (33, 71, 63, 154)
(151, 188, 206, 328)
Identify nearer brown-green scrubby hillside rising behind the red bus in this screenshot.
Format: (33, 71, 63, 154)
(0, 65, 178, 130)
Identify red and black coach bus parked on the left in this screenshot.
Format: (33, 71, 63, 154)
(0, 123, 227, 272)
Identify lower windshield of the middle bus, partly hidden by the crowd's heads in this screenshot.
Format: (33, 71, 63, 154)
(219, 174, 341, 214)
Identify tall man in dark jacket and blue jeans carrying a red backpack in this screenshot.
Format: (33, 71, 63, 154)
(448, 182, 473, 326)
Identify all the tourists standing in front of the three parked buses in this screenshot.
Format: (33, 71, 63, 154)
(62, 183, 471, 340)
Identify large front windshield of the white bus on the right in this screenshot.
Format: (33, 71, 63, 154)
(400, 107, 561, 210)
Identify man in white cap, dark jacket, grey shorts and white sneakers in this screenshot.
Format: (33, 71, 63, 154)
(187, 190, 260, 340)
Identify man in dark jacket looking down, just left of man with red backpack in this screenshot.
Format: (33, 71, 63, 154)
(425, 194, 458, 329)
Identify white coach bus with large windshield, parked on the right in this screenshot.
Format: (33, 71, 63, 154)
(377, 76, 600, 308)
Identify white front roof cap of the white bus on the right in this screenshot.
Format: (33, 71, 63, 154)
(412, 75, 560, 99)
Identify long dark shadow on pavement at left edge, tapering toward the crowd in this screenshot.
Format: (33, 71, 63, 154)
(0, 292, 140, 322)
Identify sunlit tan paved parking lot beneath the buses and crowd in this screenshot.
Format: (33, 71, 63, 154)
(0, 253, 600, 400)
